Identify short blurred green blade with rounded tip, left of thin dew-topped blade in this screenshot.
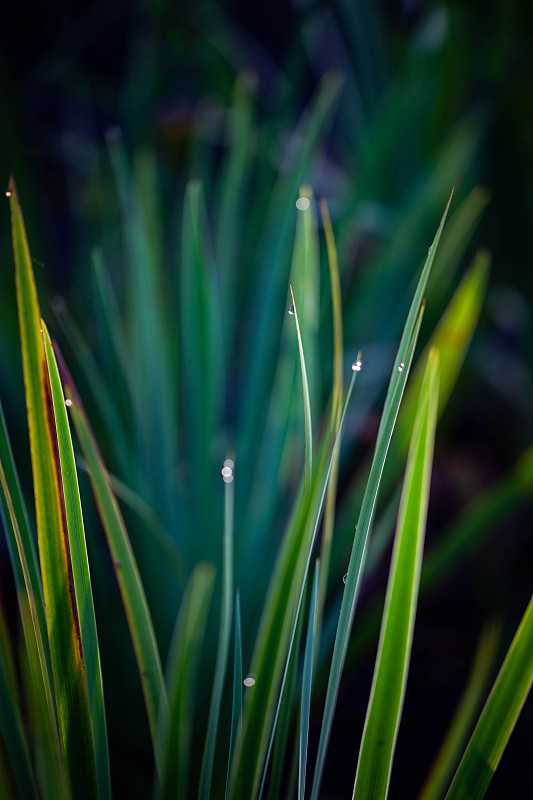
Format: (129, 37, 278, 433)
(158, 563, 215, 800)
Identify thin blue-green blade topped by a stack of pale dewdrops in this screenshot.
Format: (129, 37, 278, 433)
(198, 459, 235, 800)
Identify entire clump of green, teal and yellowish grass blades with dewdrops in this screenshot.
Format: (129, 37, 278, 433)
(0, 75, 533, 800)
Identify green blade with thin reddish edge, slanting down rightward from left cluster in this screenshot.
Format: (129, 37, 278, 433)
(58, 355, 167, 768)
